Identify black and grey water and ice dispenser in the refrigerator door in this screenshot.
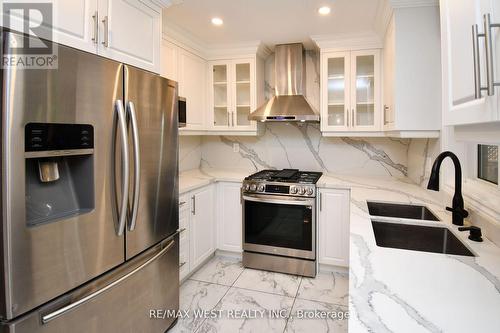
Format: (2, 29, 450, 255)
(24, 123, 95, 226)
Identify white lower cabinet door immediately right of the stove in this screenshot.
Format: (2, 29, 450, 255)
(318, 189, 350, 267)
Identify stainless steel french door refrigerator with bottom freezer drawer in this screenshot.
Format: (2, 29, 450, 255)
(0, 31, 179, 333)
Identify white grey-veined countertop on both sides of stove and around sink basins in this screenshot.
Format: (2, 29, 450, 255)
(179, 169, 500, 333)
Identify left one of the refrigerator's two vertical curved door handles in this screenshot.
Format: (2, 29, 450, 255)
(115, 99, 130, 236)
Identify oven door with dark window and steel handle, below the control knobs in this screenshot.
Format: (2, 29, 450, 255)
(242, 194, 316, 259)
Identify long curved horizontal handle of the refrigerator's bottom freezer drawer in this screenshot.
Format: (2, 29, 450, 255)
(42, 239, 175, 324)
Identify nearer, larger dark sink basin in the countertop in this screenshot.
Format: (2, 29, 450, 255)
(372, 220, 475, 257)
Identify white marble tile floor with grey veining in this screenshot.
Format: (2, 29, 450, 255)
(169, 256, 349, 333)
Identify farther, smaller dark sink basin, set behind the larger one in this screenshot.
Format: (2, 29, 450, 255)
(367, 201, 440, 221)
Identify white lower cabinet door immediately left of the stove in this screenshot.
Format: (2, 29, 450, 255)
(216, 182, 243, 252)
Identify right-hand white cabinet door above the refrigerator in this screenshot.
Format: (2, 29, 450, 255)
(98, 0, 161, 73)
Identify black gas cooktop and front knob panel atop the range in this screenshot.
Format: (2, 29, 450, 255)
(242, 169, 322, 197)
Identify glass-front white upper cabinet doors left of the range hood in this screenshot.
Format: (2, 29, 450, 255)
(210, 59, 257, 131)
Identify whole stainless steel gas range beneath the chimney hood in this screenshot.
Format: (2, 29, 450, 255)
(241, 169, 321, 276)
